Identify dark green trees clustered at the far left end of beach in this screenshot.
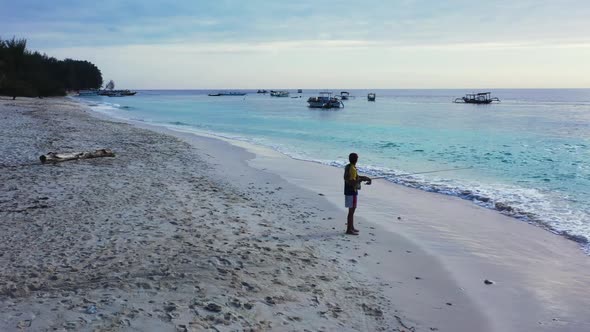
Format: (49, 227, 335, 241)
(0, 37, 103, 99)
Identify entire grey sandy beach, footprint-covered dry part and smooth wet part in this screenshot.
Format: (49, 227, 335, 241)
(0, 98, 590, 331)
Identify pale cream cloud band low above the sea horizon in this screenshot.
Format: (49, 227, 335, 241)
(48, 40, 590, 89)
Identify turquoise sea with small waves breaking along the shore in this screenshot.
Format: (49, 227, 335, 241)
(77, 89, 590, 250)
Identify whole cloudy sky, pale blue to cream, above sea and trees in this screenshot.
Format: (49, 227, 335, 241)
(0, 0, 590, 89)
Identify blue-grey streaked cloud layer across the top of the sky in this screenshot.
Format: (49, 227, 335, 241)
(6, 0, 590, 47)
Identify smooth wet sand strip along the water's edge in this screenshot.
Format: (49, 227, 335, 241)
(84, 96, 590, 331)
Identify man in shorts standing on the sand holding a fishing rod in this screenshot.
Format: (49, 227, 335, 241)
(344, 152, 371, 235)
